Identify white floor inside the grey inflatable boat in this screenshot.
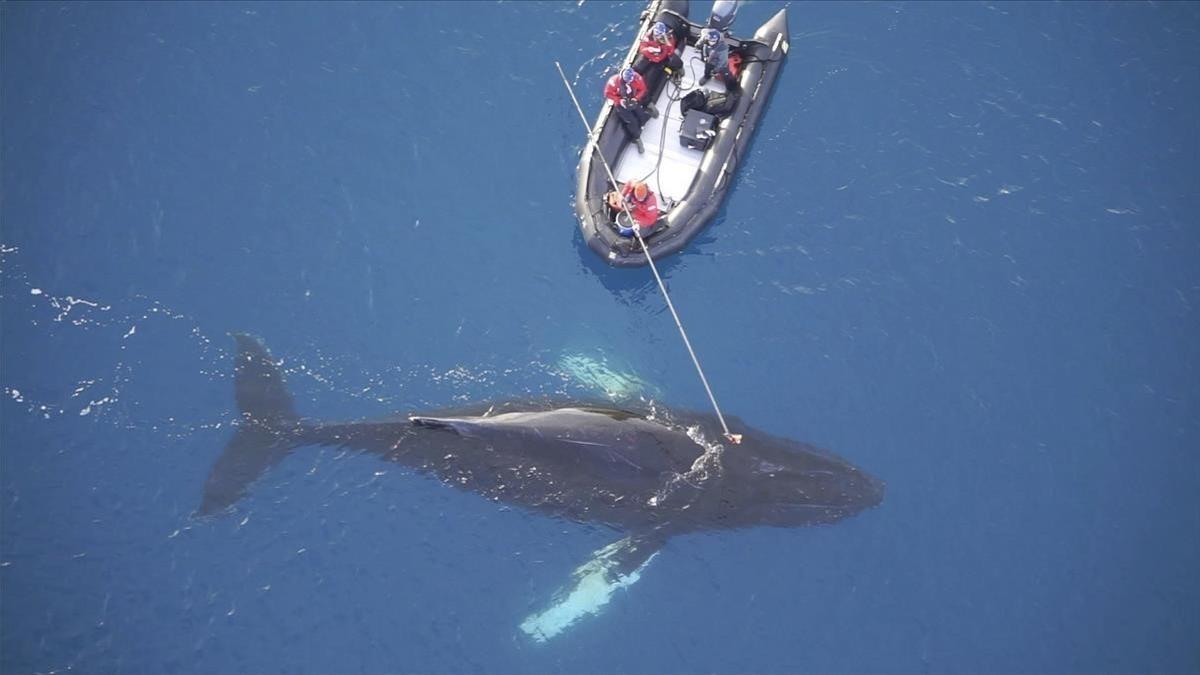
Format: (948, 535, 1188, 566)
(613, 46, 728, 202)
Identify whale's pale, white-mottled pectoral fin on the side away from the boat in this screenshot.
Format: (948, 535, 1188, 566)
(521, 533, 665, 643)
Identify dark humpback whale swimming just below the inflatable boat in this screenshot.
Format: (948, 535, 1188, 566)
(198, 334, 883, 641)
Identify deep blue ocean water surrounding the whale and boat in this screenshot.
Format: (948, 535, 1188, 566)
(0, 1, 1200, 674)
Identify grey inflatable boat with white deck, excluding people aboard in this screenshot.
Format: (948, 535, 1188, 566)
(575, 0, 788, 267)
